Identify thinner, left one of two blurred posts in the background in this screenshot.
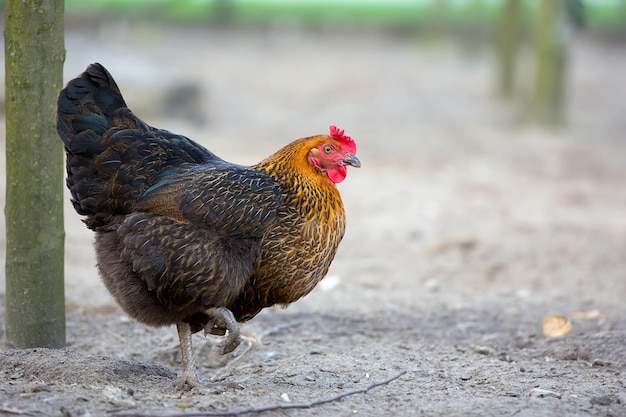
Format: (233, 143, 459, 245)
(496, 0, 520, 98)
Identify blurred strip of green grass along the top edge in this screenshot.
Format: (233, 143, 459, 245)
(65, 0, 626, 30)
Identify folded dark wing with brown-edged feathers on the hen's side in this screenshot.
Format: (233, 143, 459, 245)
(136, 161, 283, 239)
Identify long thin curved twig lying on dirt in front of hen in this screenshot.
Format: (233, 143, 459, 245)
(114, 370, 406, 417)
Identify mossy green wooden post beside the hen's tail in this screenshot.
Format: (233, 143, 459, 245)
(4, 0, 65, 348)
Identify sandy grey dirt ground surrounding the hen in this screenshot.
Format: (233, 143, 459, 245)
(0, 22, 626, 417)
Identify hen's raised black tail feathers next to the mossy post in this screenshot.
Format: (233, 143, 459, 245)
(57, 64, 217, 229)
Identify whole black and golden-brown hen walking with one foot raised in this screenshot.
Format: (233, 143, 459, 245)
(57, 64, 361, 387)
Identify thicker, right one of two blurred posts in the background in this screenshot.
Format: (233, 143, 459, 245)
(530, 0, 572, 125)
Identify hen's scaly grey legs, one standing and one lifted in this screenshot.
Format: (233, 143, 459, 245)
(176, 307, 241, 388)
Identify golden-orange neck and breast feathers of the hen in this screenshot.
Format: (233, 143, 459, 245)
(230, 143, 346, 320)
